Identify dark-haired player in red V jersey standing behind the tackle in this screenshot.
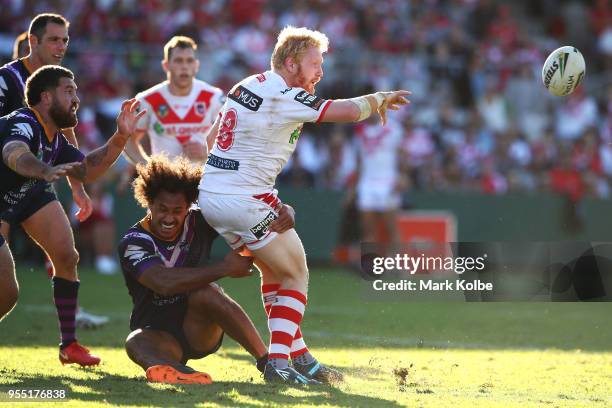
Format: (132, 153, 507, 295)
(125, 36, 225, 164)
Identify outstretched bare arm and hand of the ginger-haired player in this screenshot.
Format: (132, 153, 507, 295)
(321, 90, 410, 125)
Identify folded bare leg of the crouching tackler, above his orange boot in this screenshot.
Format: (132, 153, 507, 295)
(125, 329, 183, 366)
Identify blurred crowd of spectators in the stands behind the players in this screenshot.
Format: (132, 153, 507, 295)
(0, 0, 612, 200)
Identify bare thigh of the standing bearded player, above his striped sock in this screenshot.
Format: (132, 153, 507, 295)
(21, 200, 78, 265)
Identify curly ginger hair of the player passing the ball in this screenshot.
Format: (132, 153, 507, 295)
(270, 26, 329, 70)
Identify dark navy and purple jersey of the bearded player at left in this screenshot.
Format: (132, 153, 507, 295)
(0, 108, 84, 204)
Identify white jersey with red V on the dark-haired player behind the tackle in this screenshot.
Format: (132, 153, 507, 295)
(136, 79, 225, 158)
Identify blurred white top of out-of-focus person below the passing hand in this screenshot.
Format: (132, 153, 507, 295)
(355, 121, 403, 188)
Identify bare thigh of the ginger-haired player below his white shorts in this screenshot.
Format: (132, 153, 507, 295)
(252, 229, 308, 277)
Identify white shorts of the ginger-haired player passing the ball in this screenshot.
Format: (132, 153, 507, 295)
(199, 190, 281, 249)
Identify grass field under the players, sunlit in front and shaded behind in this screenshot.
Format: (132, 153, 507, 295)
(0, 262, 612, 407)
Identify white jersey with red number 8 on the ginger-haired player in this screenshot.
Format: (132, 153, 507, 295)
(200, 71, 331, 194)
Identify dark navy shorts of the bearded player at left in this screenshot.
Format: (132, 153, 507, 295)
(0, 181, 57, 227)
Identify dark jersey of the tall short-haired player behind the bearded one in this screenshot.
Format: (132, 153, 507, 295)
(0, 59, 30, 116)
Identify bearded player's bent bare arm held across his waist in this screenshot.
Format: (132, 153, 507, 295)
(2, 141, 80, 182)
